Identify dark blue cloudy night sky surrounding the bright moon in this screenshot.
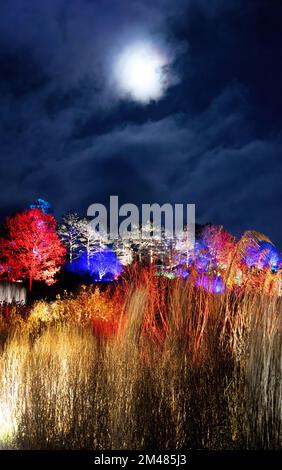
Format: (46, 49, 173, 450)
(0, 0, 282, 249)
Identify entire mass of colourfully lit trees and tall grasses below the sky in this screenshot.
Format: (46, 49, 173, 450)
(0, 200, 282, 449)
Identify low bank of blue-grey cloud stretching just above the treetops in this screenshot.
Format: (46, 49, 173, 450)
(1, 81, 282, 241)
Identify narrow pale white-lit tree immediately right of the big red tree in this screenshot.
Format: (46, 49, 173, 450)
(58, 212, 83, 263)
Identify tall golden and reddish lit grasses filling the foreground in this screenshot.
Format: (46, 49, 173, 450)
(0, 272, 282, 449)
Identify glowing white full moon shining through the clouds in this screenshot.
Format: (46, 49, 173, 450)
(115, 43, 168, 104)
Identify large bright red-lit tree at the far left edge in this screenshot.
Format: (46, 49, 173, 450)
(0, 209, 65, 290)
